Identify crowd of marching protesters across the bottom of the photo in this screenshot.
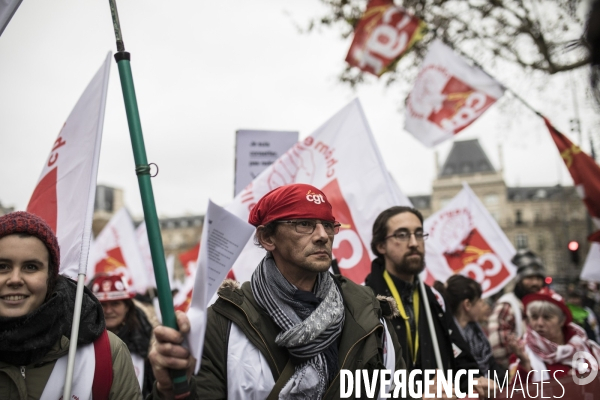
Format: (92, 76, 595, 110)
(0, 184, 600, 400)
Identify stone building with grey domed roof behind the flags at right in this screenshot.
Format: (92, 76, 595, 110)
(410, 139, 591, 285)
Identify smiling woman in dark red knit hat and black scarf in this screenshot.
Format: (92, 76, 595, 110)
(0, 212, 141, 400)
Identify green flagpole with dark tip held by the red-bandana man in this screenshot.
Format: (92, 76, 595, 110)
(109, 0, 190, 399)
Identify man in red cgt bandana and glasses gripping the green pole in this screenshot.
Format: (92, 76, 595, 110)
(149, 184, 405, 399)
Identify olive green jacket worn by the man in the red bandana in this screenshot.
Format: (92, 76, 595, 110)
(162, 275, 405, 399)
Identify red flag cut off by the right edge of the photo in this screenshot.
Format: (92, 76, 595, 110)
(544, 117, 600, 228)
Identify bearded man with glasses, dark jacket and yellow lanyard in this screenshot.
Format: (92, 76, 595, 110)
(365, 206, 477, 388)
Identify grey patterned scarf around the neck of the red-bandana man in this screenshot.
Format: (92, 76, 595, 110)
(251, 253, 344, 399)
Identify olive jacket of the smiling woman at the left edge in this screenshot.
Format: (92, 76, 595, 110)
(0, 332, 142, 400)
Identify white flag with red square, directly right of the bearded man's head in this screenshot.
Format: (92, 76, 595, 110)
(422, 183, 516, 297)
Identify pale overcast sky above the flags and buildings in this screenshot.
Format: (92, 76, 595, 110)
(0, 0, 598, 217)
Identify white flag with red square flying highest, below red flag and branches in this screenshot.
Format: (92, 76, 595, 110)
(404, 39, 504, 147)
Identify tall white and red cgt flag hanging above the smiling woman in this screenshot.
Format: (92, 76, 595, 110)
(27, 53, 111, 279)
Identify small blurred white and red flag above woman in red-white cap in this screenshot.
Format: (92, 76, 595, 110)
(89, 208, 151, 293)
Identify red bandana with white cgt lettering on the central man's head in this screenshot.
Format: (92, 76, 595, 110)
(248, 183, 335, 226)
